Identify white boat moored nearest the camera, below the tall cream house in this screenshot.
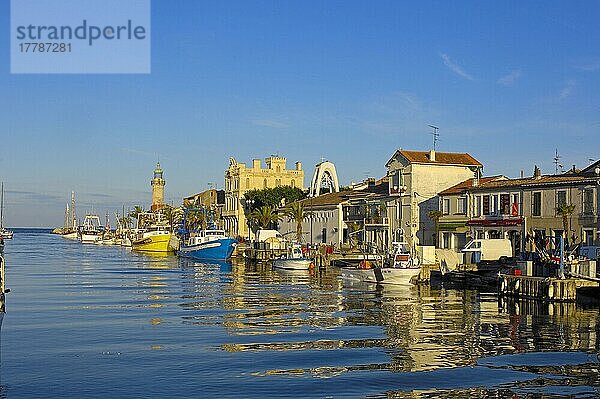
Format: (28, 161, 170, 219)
(341, 242, 421, 285)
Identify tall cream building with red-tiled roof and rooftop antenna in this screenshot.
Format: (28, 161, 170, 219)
(385, 149, 483, 249)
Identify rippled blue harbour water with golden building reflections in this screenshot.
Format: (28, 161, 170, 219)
(0, 230, 600, 398)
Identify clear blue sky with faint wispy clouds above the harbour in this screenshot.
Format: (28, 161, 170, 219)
(0, 0, 600, 226)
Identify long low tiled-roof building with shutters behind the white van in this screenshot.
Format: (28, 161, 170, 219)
(439, 162, 600, 255)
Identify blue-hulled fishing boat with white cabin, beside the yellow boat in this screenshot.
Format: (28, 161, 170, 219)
(177, 209, 237, 260)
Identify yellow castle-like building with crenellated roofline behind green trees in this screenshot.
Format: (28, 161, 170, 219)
(223, 155, 304, 237)
